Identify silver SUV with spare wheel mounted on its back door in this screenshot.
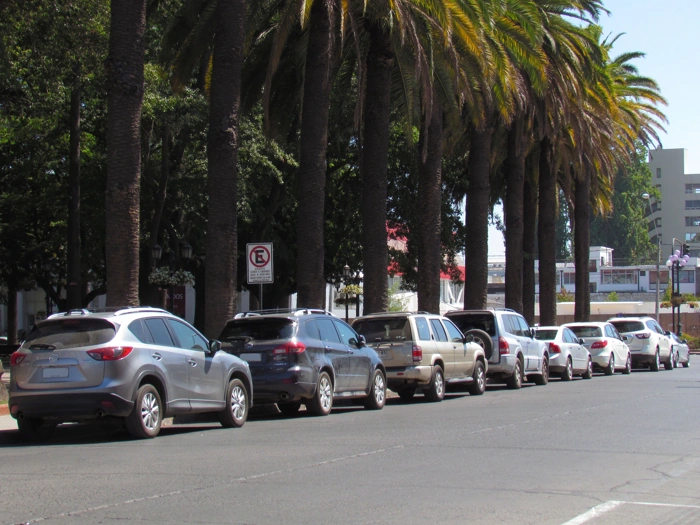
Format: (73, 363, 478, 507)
(445, 308, 549, 389)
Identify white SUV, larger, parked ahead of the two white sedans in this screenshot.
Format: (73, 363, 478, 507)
(608, 317, 673, 372)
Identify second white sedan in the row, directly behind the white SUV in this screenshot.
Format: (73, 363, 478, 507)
(563, 321, 632, 376)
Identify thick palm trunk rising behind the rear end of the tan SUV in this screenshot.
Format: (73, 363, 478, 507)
(358, 25, 394, 314)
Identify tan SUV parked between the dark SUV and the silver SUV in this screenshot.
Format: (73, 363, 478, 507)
(352, 312, 488, 401)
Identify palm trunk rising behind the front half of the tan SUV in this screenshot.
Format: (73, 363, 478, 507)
(417, 93, 443, 314)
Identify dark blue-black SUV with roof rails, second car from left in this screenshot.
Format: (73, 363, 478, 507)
(220, 308, 386, 416)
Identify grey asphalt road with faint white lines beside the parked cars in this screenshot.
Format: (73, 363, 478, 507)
(0, 361, 700, 525)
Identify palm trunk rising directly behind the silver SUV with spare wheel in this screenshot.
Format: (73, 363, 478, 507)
(464, 122, 495, 310)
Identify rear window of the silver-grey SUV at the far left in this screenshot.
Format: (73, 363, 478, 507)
(24, 319, 117, 350)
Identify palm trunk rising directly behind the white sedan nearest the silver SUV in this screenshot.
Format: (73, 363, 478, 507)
(537, 137, 557, 326)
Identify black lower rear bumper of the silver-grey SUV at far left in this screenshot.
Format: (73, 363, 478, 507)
(8, 392, 134, 421)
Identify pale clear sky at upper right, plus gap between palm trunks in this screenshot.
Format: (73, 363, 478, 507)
(489, 0, 700, 255)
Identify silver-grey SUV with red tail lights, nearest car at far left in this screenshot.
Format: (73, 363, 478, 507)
(9, 308, 253, 438)
